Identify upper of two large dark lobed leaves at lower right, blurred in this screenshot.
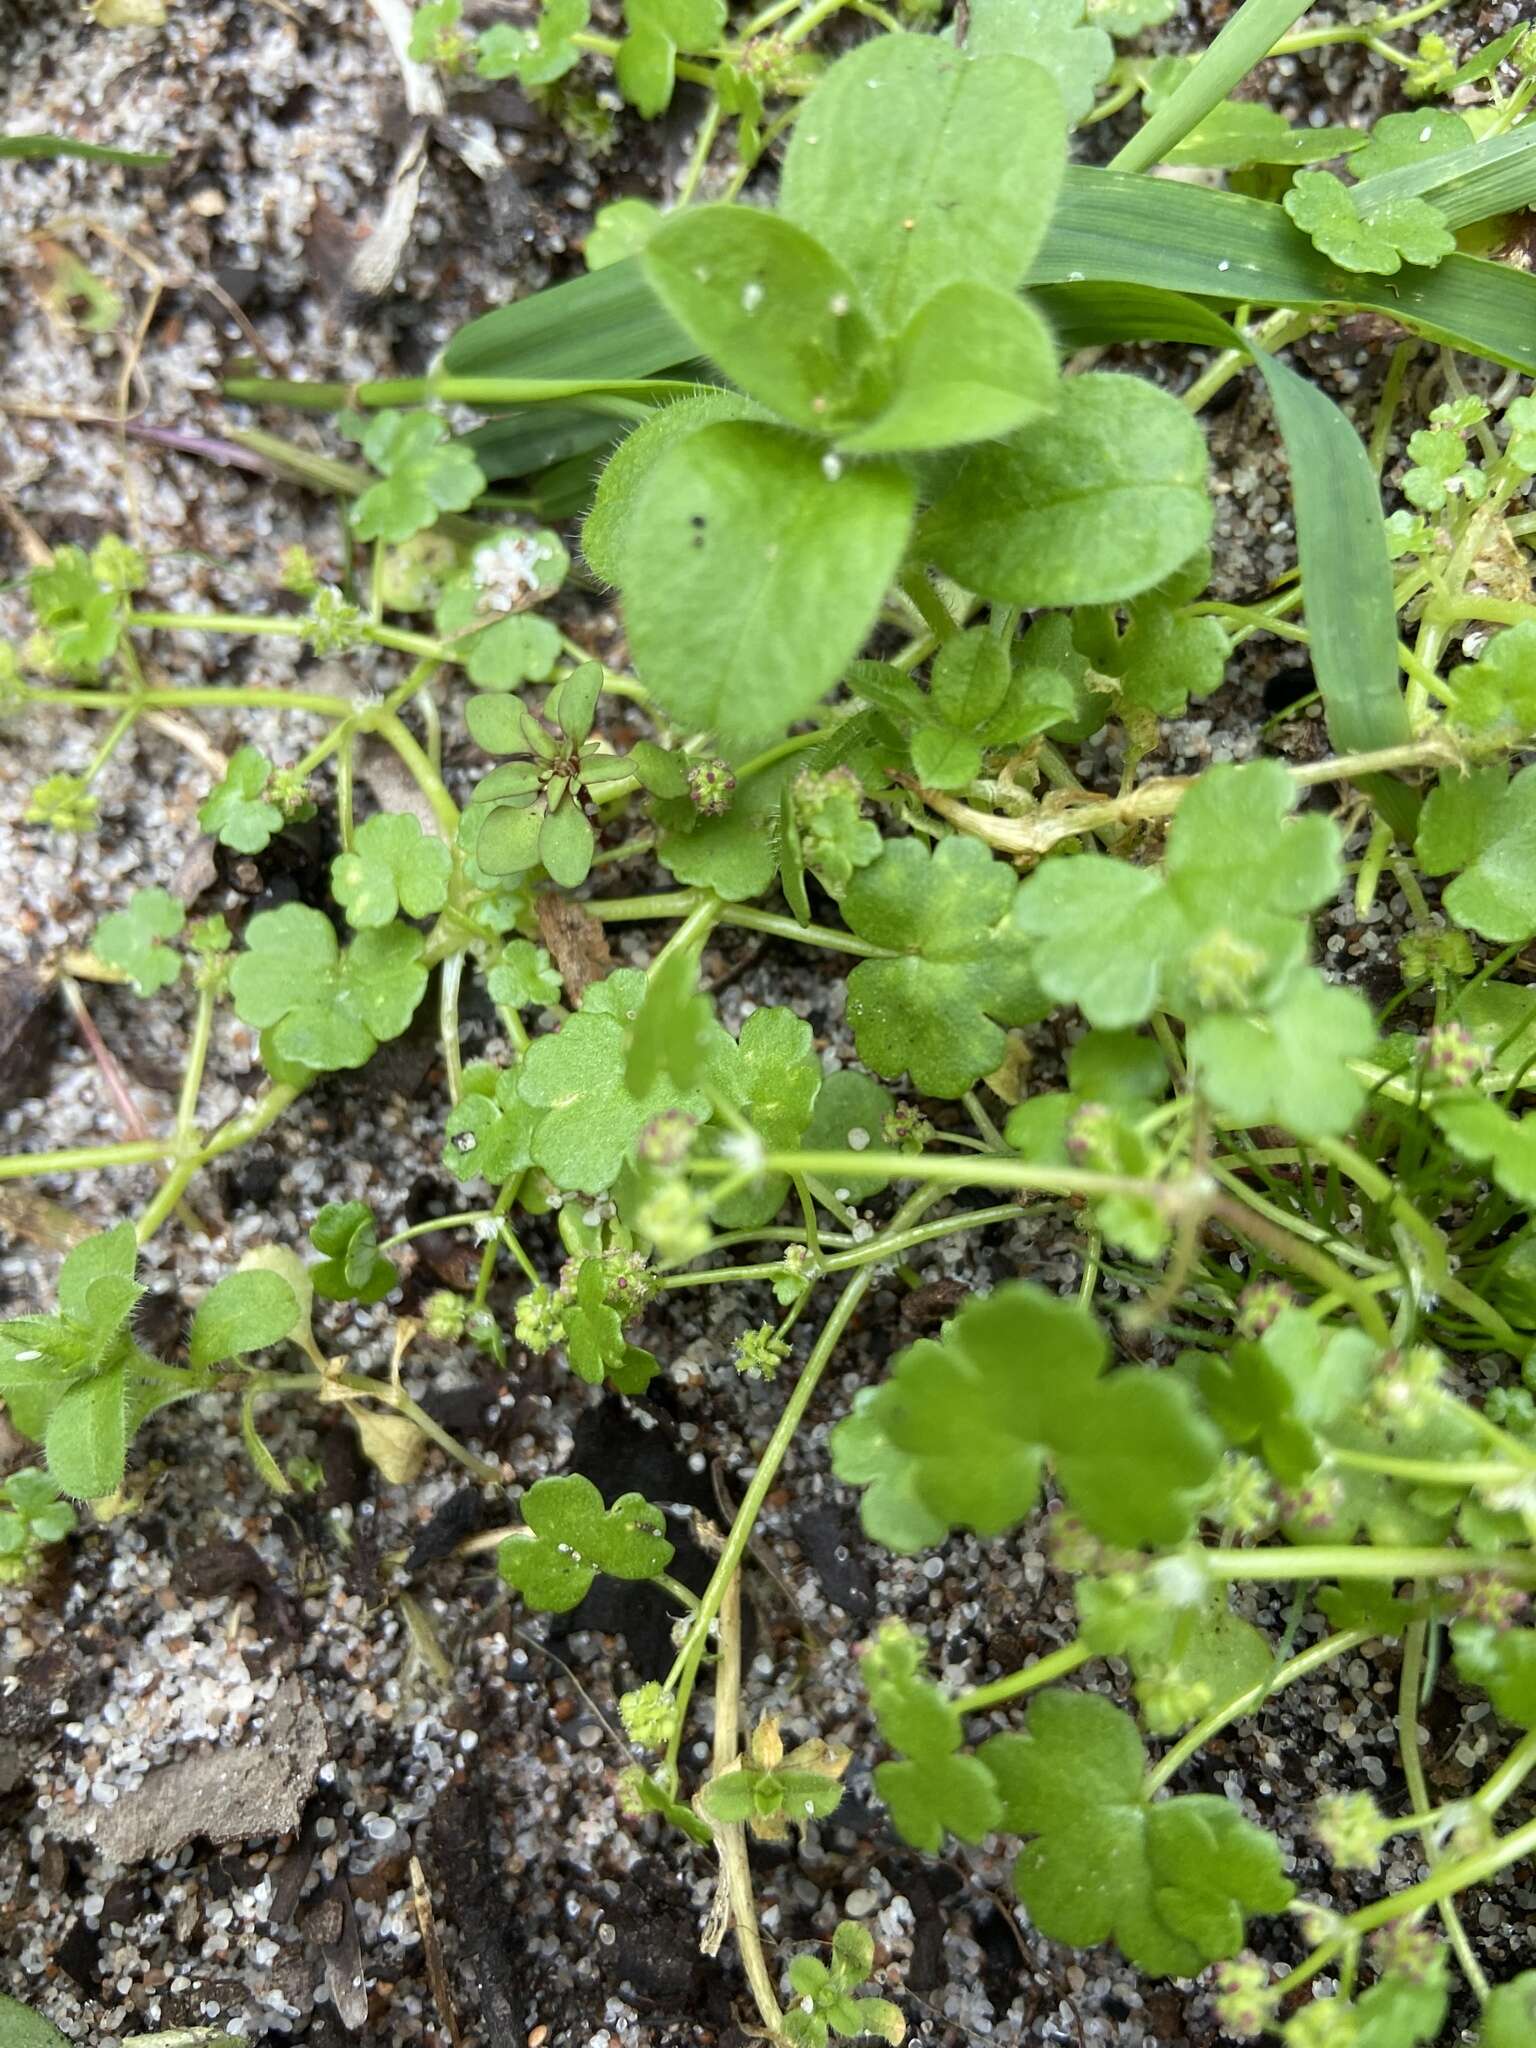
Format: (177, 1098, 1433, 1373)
(831, 1282, 1221, 1546)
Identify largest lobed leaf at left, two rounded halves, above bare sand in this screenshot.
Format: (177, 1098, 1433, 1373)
(229, 903, 426, 1073)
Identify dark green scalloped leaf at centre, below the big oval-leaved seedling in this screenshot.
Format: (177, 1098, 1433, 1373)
(842, 838, 1044, 1098)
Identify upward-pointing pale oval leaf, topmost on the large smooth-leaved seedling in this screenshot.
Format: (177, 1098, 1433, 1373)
(780, 35, 1067, 332)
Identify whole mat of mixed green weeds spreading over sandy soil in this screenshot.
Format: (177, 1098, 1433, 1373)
(0, 0, 1536, 2048)
